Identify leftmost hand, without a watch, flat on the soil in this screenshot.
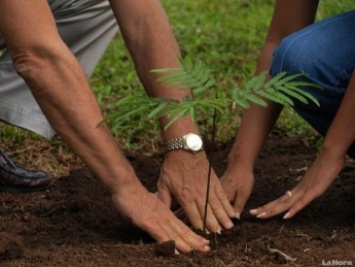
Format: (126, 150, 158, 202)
(112, 179, 210, 253)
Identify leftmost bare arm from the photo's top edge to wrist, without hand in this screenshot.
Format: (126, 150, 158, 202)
(0, 0, 138, 194)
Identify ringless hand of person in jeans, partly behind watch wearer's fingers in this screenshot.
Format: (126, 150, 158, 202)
(221, 166, 254, 219)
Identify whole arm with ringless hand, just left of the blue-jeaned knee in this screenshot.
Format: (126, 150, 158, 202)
(222, 0, 318, 217)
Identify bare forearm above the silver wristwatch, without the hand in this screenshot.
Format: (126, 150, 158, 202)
(110, 0, 198, 140)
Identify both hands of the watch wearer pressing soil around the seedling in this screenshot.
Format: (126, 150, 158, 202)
(112, 151, 236, 253)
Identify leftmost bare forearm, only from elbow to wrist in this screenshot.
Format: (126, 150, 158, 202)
(20, 48, 135, 193)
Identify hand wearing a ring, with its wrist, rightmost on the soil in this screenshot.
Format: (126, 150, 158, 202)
(250, 152, 344, 219)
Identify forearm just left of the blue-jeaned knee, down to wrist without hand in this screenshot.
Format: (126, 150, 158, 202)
(229, 0, 318, 169)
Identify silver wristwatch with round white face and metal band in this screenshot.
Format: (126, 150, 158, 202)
(165, 133, 203, 153)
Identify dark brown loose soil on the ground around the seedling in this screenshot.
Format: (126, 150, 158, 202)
(0, 135, 355, 267)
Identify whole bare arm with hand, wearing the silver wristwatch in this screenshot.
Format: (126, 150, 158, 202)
(110, 0, 235, 232)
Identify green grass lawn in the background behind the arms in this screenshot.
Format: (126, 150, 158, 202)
(0, 0, 355, 159)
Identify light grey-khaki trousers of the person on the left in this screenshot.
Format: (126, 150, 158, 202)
(0, 0, 118, 139)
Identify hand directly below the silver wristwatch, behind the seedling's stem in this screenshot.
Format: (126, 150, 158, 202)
(157, 150, 235, 233)
